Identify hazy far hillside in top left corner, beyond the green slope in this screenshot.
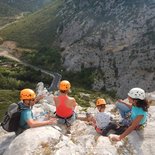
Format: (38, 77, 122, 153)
(0, 0, 52, 29)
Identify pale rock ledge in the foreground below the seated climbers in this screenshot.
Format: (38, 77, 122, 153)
(0, 106, 155, 155)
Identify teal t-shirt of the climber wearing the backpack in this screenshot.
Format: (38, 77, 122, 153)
(19, 103, 33, 129)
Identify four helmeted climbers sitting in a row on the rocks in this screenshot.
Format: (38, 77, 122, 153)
(8, 83, 149, 141)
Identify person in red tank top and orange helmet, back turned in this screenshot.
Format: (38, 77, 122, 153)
(54, 80, 78, 127)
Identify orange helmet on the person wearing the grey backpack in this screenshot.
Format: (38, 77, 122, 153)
(20, 89, 36, 100)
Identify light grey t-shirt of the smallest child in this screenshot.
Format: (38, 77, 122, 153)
(95, 112, 112, 129)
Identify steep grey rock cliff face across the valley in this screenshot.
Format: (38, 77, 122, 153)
(57, 0, 155, 97)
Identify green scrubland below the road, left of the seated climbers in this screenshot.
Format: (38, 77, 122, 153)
(0, 57, 52, 120)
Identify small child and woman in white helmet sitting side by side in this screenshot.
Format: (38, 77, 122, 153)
(79, 88, 149, 141)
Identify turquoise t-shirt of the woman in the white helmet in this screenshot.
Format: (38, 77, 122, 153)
(131, 106, 147, 125)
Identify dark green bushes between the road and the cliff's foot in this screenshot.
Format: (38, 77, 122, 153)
(19, 47, 98, 89)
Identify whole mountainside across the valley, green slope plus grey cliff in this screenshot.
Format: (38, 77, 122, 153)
(0, 0, 155, 97)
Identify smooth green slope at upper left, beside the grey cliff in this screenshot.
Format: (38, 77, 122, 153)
(0, 0, 62, 49)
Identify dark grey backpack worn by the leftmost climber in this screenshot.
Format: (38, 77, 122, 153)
(1, 103, 22, 132)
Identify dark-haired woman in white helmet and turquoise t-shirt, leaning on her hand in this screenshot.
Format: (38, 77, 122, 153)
(109, 88, 149, 141)
